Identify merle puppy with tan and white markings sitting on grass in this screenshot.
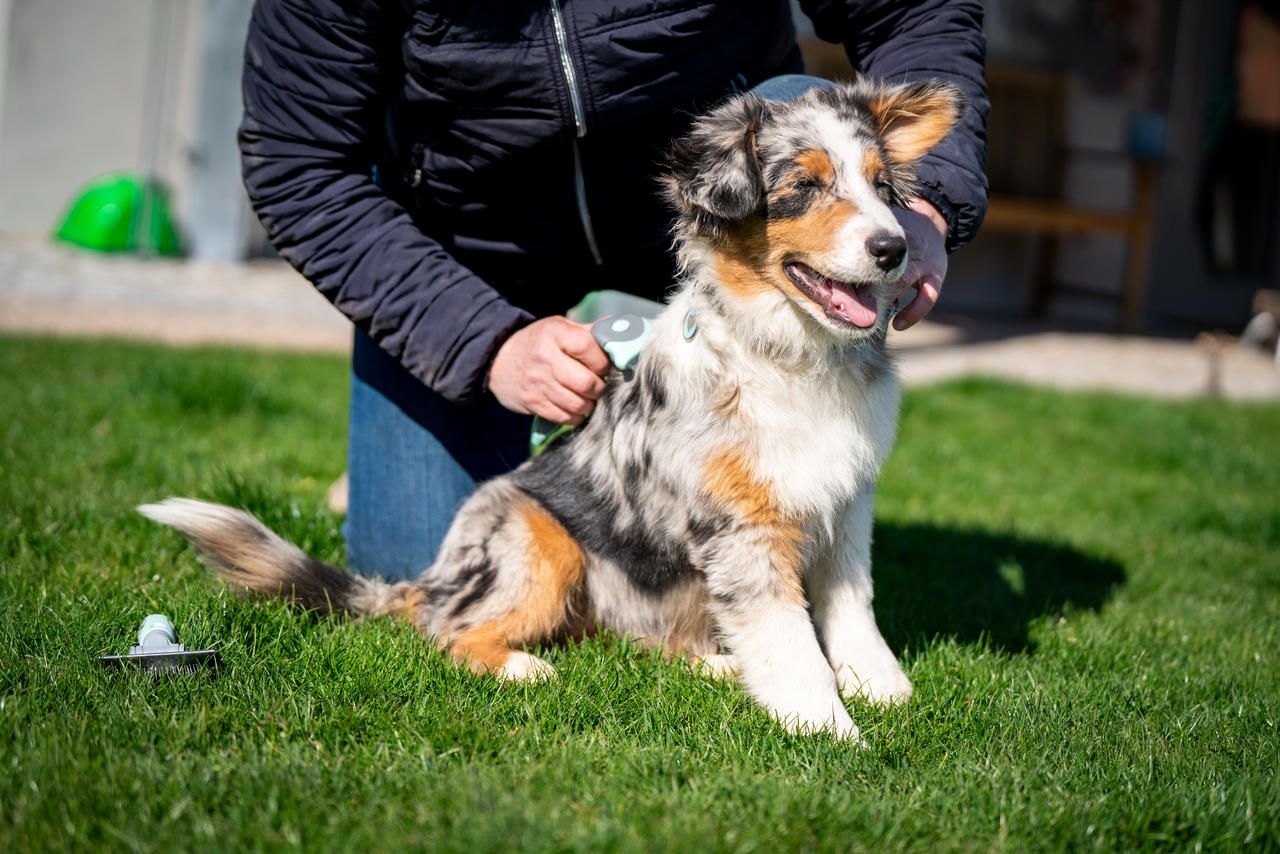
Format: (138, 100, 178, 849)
(140, 81, 963, 741)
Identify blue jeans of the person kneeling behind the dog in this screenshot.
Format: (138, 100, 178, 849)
(342, 74, 831, 580)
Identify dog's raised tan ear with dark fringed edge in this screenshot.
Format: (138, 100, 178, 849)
(867, 81, 964, 165)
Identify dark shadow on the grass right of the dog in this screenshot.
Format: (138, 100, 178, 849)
(872, 522, 1125, 653)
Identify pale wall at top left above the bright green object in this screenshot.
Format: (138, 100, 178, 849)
(0, 0, 200, 234)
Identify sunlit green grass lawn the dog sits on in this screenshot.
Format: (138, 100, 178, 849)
(0, 338, 1280, 851)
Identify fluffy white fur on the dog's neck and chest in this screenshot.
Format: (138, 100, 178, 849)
(649, 289, 899, 524)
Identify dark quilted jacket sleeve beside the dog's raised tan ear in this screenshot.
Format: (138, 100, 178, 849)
(801, 0, 989, 251)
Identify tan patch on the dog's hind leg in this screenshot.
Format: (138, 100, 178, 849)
(437, 499, 586, 672)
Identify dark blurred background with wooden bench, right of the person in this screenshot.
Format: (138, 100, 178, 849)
(803, 0, 1280, 332)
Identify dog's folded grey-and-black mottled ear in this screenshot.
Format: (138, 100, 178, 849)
(666, 93, 768, 233)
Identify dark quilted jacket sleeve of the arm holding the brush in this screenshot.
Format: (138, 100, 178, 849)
(239, 0, 532, 403)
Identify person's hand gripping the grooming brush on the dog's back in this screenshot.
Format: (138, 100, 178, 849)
(489, 316, 609, 424)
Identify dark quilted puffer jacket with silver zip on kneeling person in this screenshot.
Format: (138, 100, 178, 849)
(241, 0, 987, 402)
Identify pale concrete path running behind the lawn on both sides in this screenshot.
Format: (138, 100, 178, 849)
(0, 238, 1280, 399)
